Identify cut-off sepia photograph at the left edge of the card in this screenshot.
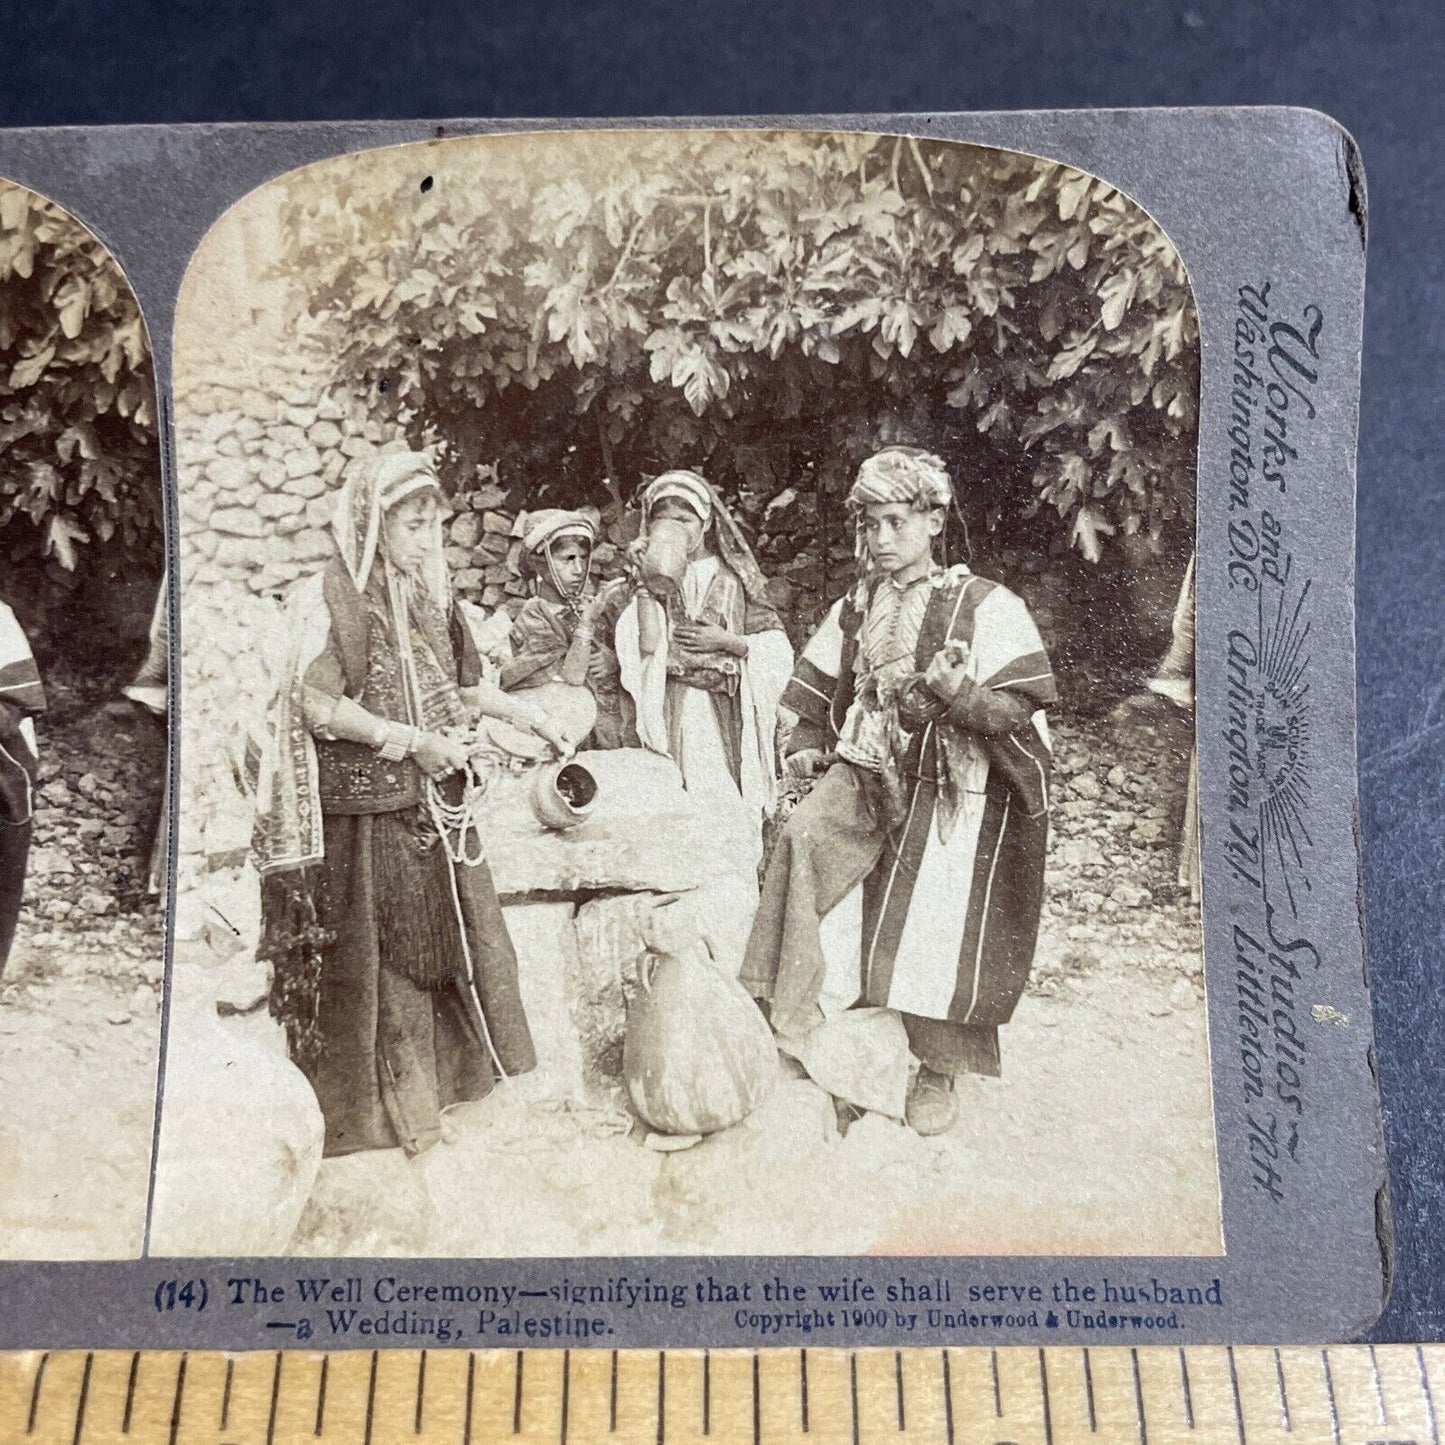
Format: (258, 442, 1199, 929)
(0, 179, 168, 1260)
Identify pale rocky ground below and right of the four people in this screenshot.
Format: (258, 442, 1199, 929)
(292, 702, 1221, 1257)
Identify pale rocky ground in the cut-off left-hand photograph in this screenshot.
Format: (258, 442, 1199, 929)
(0, 668, 165, 1259)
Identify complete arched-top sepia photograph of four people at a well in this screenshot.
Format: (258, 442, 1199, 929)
(155, 130, 1224, 1259)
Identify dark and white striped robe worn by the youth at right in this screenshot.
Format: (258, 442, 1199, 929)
(744, 566, 1056, 1035)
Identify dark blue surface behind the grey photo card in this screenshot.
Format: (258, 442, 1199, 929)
(0, 0, 1445, 1338)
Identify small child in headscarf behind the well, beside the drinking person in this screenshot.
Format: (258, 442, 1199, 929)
(500, 507, 634, 747)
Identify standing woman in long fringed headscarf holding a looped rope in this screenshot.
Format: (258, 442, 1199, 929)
(257, 452, 565, 1155)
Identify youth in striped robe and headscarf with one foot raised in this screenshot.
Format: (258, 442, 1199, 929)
(741, 447, 1055, 1134)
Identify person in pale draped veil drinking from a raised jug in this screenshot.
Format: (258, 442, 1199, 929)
(617, 471, 793, 857)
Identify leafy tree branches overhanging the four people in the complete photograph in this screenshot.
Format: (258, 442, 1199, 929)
(278, 131, 1198, 574)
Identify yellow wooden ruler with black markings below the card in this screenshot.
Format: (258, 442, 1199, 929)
(0, 1345, 1445, 1445)
